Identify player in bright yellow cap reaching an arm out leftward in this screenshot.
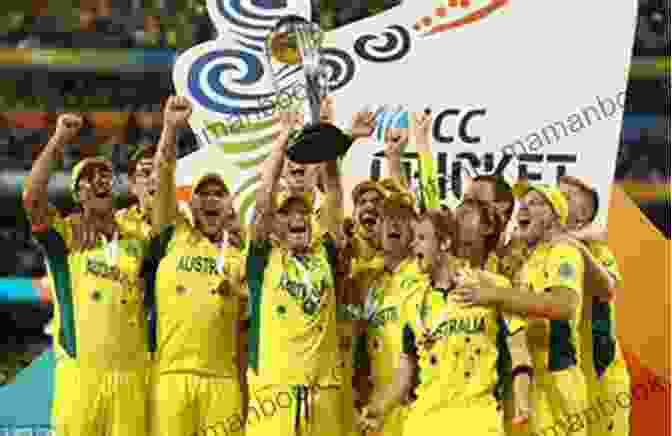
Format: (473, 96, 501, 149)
(456, 183, 588, 435)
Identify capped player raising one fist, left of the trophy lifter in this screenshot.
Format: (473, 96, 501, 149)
(144, 97, 246, 436)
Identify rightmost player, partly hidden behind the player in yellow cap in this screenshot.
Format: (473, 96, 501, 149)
(559, 176, 630, 436)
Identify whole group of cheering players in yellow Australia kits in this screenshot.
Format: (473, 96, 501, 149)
(23, 97, 629, 436)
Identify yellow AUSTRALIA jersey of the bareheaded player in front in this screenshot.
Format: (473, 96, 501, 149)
(403, 268, 511, 414)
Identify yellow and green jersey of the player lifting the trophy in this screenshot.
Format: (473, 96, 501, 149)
(247, 236, 339, 386)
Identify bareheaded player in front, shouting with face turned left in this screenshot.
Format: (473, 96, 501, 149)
(363, 210, 524, 435)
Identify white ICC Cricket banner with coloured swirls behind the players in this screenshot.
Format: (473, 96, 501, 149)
(174, 0, 636, 220)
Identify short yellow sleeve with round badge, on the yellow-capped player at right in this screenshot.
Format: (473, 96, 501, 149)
(544, 244, 585, 295)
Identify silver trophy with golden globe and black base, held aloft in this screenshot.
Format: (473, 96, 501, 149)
(266, 15, 352, 164)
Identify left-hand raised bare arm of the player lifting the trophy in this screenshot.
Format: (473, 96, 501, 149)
(250, 111, 300, 241)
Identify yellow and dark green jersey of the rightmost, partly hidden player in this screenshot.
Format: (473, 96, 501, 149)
(587, 241, 628, 378)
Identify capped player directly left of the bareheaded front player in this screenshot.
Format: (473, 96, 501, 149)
(352, 192, 424, 435)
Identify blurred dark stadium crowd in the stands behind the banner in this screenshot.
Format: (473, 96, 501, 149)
(0, 0, 670, 378)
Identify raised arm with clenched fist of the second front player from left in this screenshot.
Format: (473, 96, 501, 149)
(152, 96, 192, 234)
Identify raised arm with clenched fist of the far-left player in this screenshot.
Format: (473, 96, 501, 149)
(23, 114, 83, 229)
